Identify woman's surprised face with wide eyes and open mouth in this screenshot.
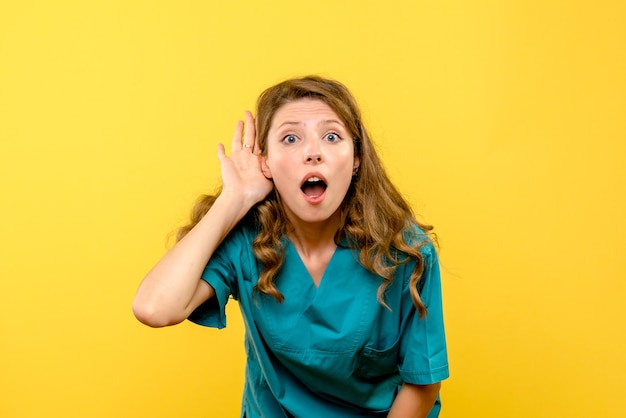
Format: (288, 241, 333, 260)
(263, 99, 359, 224)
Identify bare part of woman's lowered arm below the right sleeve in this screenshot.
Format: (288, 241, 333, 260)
(387, 382, 441, 418)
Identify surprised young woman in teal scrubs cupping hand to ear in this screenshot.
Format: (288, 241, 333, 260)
(133, 76, 448, 418)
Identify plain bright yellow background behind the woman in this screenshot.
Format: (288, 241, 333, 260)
(0, 0, 626, 418)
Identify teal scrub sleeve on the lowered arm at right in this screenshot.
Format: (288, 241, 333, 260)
(398, 243, 450, 385)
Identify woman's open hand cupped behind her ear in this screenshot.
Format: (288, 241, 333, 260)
(217, 111, 274, 207)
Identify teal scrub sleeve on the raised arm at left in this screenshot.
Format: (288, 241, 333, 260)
(188, 229, 241, 329)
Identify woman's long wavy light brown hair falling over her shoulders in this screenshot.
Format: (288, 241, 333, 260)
(177, 76, 432, 317)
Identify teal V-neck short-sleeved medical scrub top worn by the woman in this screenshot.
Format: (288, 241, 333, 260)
(189, 226, 449, 418)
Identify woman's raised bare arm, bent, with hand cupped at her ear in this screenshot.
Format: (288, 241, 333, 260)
(133, 112, 273, 327)
